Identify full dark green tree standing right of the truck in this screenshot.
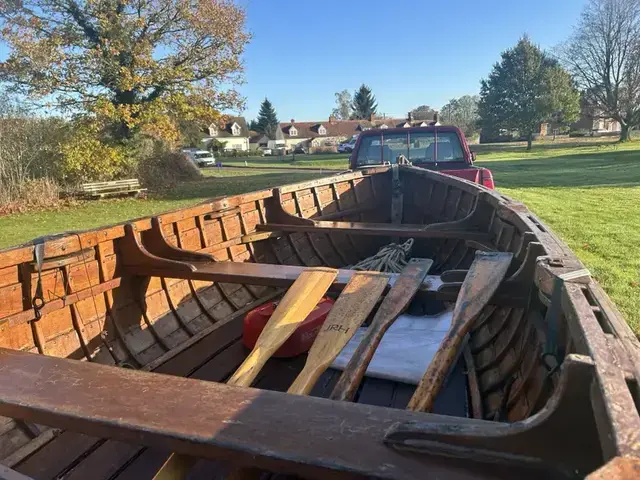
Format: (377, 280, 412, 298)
(478, 36, 580, 150)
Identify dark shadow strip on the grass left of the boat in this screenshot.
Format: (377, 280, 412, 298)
(154, 171, 329, 200)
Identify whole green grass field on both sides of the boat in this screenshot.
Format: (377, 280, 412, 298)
(0, 141, 640, 334)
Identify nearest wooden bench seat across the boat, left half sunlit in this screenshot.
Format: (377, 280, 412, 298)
(0, 349, 496, 480)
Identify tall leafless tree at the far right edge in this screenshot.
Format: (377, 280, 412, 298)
(560, 0, 640, 141)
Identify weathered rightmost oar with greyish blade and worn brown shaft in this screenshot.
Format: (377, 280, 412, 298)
(407, 252, 513, 412)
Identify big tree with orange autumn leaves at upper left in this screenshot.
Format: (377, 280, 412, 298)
(0, 0, 249, 142)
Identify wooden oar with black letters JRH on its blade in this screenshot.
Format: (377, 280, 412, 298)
(288, 272, 390, 395)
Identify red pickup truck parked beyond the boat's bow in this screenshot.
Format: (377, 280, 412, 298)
(350, 125, 494, 189)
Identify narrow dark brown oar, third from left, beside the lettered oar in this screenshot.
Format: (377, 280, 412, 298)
(329, 259, 433, 401)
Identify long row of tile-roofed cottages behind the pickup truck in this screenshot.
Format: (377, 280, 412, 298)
(280, 114, 432, 152)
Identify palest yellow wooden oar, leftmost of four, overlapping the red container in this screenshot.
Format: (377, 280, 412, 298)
(153, 268, 338, 480)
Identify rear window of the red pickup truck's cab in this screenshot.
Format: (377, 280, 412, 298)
(356, 132, 464, 166)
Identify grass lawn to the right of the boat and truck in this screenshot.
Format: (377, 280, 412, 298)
(477, 142, 640, 335)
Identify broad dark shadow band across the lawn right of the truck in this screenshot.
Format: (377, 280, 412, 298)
(476, 151, 640, 188)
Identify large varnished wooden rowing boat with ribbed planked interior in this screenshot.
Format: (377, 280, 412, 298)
(0, 166, 640, 480)
